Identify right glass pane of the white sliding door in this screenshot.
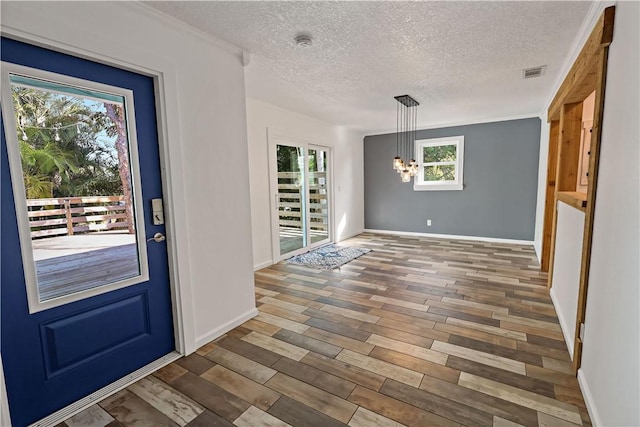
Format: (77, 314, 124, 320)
(309, 149, 329, 244)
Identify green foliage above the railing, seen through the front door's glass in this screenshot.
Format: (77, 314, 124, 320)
(12, 85, 122, 199)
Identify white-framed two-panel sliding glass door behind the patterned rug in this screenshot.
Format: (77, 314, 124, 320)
(269, 135, 331, 262)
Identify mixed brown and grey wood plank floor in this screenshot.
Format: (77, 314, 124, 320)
(56, 233, 590, 427)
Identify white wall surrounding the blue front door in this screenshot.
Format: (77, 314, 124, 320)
(2, 1, 255, 353)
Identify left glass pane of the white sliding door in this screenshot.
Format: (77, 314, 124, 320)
(276, 145, 307, 255)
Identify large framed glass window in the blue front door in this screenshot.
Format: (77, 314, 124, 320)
(3, 64, 148, 311)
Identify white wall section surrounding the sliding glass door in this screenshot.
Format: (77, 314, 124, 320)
(247, 98, 364, 268)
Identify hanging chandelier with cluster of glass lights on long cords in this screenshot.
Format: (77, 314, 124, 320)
(393, 95, 420, 182)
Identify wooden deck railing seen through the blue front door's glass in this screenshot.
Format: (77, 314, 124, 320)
(27, 196, 129, 239)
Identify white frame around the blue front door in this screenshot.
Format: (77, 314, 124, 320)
(0, 24, 190, 424)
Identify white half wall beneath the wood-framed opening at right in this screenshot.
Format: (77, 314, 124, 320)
(550, 202, 584, 356)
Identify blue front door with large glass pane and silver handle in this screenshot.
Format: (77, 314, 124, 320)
(0, 38, 175, 426)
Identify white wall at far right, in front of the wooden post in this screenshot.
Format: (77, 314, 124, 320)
(578, 2, 640, 426)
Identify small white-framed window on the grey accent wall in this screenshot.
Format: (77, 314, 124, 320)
(413, 136, 464, 191)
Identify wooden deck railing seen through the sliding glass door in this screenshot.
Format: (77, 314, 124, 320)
(277, 172, 329, 231)
